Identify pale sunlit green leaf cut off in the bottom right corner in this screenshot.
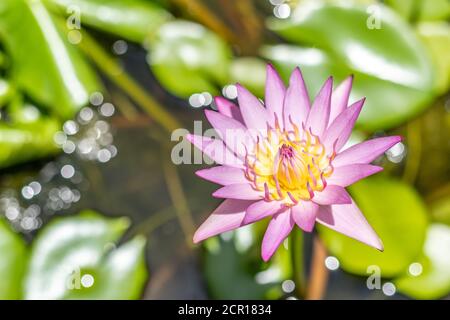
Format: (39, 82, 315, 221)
(395, 224, 450, 299)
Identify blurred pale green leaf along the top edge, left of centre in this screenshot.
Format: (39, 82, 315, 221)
(44, 0, 171, 43)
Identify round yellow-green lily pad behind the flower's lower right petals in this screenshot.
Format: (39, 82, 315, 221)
(319, 177, 428, 277)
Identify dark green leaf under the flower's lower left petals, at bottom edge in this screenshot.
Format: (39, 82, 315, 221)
(203, 221, 292, 299)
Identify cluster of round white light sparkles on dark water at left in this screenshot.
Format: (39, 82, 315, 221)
(0, 92, 117, 234)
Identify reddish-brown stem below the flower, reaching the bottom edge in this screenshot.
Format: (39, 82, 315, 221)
(306, 235, 328, 300)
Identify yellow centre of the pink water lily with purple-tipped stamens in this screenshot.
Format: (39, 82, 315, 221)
(246, 120, 335, 205)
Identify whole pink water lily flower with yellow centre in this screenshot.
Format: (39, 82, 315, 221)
(187, 65, 401, 261)
